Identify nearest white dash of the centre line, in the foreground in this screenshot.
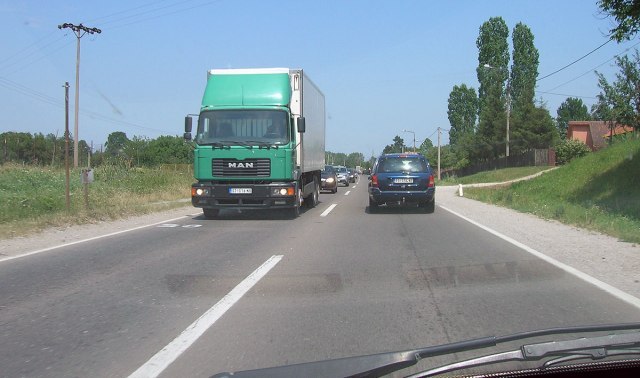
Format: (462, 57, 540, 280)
(129, 255, 283, 378)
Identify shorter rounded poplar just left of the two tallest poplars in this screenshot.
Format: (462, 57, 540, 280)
(447, 84, 478, 144)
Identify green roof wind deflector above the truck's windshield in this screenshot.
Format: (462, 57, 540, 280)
(202, 73, 291, 109)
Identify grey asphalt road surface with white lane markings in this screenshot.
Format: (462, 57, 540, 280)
(0, 180, 640, 377)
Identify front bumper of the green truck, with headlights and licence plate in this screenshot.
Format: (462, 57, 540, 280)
(191, 183, 298, 209)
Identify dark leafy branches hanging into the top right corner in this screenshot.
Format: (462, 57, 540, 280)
(598, 0, 640, 42)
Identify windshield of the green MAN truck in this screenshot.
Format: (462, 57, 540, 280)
(195, 110, 290, 145)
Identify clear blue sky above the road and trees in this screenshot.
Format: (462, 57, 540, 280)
(0, 0, 638, 157)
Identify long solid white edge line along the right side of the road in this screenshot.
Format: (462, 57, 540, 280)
(438, 205, 640, 309)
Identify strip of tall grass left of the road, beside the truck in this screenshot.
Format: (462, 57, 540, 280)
(0, 164, 193, 239)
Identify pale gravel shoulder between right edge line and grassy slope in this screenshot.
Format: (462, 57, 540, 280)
(436, 186, 640, 298)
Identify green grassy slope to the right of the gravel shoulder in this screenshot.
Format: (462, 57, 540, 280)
(465, 139, 640, 243)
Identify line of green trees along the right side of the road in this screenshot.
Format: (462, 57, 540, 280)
(383, 8, 640, 168)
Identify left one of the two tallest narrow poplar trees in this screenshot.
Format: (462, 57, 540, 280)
(475, 17, 509, 159)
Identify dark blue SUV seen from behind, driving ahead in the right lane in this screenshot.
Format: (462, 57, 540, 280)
(369, 153, 436, 213)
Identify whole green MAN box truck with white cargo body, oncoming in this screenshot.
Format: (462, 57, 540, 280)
(184, 68, 325, 219)
